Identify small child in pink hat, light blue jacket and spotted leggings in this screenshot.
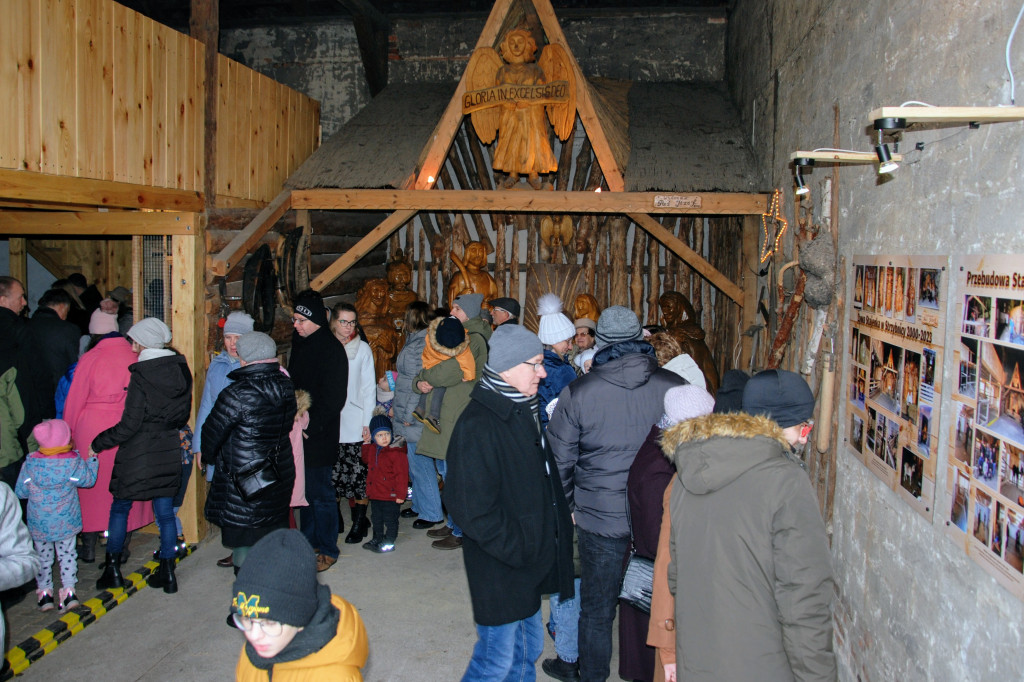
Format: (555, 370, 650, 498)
(14, 419, 99, 613)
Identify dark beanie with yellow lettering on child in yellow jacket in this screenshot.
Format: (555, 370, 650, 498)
(231, 528, 319, 628)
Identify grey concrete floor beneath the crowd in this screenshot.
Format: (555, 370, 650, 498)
(7, 519, 606, 682)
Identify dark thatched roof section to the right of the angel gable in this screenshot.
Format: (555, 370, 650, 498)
(626, 83, 760, 193)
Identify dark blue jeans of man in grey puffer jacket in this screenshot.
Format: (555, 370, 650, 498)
(577, 526, 630, 682)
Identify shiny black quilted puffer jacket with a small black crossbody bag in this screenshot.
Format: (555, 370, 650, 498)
(203, 363, 296, 528)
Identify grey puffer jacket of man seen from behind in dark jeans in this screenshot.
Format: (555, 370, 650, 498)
(547, 342, 686, 538)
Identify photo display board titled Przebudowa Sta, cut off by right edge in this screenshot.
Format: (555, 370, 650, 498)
(946, 256, 1024, 599)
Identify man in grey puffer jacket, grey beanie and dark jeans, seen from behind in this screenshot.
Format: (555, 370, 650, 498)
(547, 305, 686, 681)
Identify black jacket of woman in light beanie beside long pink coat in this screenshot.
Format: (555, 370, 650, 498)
(92, 353, 191, 500)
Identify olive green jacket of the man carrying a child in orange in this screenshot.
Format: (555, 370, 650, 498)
(413, 317, 490, 460)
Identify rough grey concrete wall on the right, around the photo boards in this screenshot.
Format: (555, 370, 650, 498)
(727, 0, 1024, 681)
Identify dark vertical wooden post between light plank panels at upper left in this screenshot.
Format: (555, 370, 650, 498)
(188, 0, 220, 206)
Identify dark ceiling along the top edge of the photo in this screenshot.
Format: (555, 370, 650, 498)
(120, 0, 730, 33)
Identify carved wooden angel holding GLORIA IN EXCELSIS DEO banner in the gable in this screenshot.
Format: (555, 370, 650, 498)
(462, 29, 575, 189)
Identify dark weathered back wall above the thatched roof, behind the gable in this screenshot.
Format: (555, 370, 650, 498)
(220, 10, 726, 139)
